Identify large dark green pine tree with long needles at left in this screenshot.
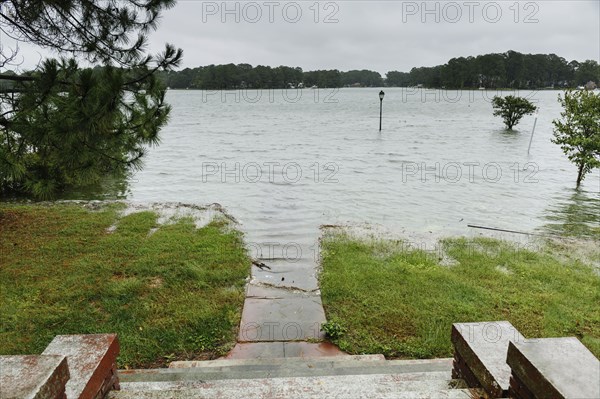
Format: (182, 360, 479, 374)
(0, 0, 182, 198)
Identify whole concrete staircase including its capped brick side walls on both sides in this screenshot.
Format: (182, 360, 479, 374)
(0, 321, 600, 399)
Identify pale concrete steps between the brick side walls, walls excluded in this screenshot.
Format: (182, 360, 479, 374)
(108, 355, 482, 399)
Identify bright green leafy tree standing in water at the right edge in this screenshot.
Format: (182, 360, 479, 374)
(552, 90, 600, 187)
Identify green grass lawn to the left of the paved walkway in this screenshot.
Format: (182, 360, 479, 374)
(0, 204, 250, 368)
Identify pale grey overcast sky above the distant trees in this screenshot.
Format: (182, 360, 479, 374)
(0, 0, 600, 74)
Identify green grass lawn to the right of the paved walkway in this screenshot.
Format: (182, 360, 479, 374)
(320, 234, 600, 358)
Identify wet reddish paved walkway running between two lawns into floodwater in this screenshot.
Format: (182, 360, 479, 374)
(228, 252, 344, 359)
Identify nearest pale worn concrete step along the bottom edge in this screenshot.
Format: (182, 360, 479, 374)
(108, 373, 479, 399)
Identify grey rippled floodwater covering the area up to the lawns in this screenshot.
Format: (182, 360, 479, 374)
(59, 88, 600, 278)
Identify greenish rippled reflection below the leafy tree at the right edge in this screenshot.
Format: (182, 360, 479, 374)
(542, 189, 600, 240)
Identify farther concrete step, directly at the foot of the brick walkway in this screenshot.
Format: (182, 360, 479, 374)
(119, 356, 452, 382)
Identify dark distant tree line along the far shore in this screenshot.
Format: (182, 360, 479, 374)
(159, 50, 600, 90)
